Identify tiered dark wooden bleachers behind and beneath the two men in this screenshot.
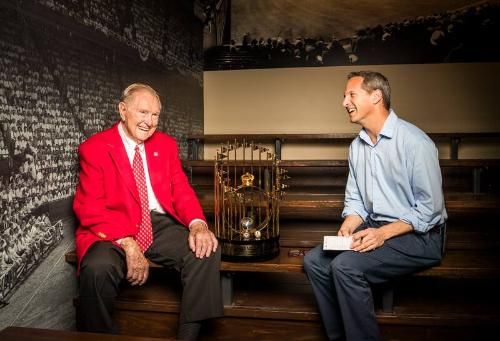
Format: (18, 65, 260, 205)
(66, 129, 500, 341)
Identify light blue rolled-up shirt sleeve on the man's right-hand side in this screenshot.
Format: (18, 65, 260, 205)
(399, 143, 446, 233)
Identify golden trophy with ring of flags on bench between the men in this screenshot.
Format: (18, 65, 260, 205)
(214, 140, 288, 261)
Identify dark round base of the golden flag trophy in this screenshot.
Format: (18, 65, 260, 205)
(219, 236, 280, 262)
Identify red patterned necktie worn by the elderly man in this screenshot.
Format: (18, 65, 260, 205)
(132, 146, 153, 252)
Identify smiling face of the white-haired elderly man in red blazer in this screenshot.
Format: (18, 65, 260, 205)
(118, 89, 160, 144)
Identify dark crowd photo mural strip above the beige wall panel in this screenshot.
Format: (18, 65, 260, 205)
(205, 0, 500, 70)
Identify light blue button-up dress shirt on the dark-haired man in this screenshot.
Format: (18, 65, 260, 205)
(342, 109, 447, 233)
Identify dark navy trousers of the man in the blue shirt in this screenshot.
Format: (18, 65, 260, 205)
(304, 221, 442, 341)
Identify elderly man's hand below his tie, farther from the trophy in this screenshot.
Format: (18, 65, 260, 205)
(120, 237, 149, 285)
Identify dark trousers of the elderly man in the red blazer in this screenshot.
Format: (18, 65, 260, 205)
(77, 212, 223, 334)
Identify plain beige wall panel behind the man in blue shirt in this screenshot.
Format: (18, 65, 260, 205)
(204, 63, 500, 159)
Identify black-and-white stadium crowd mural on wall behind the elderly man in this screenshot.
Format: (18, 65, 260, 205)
(0, 0, 203, 305)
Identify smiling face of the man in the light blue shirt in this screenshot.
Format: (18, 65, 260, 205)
(342, 77, 376, 125)
